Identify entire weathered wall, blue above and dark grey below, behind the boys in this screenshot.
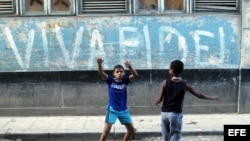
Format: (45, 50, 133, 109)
(0, 0, 250, 116)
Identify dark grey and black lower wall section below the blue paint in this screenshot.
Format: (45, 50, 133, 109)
(0, 69, 239, 116)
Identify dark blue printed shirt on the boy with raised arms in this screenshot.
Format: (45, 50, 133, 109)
(106, 75, 130, 111)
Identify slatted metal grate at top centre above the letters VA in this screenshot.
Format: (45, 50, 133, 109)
(81, 0, 127, 13)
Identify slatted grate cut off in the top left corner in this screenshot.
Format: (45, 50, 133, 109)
(0, 0, 15, 14)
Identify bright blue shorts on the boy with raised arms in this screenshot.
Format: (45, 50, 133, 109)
(105, 106, 132, 125)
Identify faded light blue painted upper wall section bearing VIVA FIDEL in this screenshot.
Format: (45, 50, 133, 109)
(0, 16, 241, 72)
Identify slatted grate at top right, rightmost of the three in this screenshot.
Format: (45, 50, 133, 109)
(194, 0, 238, 12)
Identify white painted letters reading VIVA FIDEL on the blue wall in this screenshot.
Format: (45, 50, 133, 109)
(0, 23, 235, 70)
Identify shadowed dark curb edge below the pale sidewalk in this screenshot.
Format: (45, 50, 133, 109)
(0, 131, 223, 141)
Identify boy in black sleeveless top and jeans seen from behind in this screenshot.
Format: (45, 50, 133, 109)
(155, 60, 218, 141)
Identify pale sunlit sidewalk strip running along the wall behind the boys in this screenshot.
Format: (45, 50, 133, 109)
(0, 113, 250, 140)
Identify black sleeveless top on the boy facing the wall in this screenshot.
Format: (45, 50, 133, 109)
(161, 78, 187, 113)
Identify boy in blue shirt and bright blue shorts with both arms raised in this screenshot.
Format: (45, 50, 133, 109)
(96, 58, 138, 141)
